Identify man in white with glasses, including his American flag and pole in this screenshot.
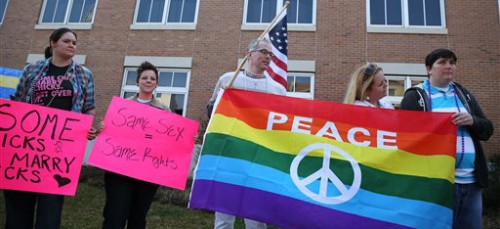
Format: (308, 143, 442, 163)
(197, 2, 290, 229)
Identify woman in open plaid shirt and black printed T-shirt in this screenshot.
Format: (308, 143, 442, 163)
(4, 28, 97, 229)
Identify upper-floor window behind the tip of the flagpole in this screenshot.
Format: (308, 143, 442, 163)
(244, 0, 316, 25)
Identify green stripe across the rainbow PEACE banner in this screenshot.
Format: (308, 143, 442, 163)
(202, 133, 453, 208)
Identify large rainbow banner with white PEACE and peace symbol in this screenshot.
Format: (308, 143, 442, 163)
(189, 89, 456, 228)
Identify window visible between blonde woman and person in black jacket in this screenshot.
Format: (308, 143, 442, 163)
(384, 74, 427, 107)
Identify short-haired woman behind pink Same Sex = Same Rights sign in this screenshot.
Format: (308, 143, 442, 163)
(99, 61, 170, 229)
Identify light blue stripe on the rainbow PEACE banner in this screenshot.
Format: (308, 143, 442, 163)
(195, 155, 452, 228)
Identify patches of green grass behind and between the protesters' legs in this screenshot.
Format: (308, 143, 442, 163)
(0, 165, 500, 229)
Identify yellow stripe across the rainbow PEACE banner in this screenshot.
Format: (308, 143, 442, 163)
(207, 114, 455, 183)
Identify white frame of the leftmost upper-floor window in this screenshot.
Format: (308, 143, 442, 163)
(35, 0, 99, 29)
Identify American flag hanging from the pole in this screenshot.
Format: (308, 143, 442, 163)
(266, 10, 288, 89)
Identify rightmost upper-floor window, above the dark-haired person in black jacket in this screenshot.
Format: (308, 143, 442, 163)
(367, 0, 445, 33)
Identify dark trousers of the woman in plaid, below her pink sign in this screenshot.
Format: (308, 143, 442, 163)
(4, 190, 64, 229)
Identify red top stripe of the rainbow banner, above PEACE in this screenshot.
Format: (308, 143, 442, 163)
(222, 89, 457, 135)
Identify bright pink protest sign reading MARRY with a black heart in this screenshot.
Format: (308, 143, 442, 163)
(0, 99, 93, 196)
